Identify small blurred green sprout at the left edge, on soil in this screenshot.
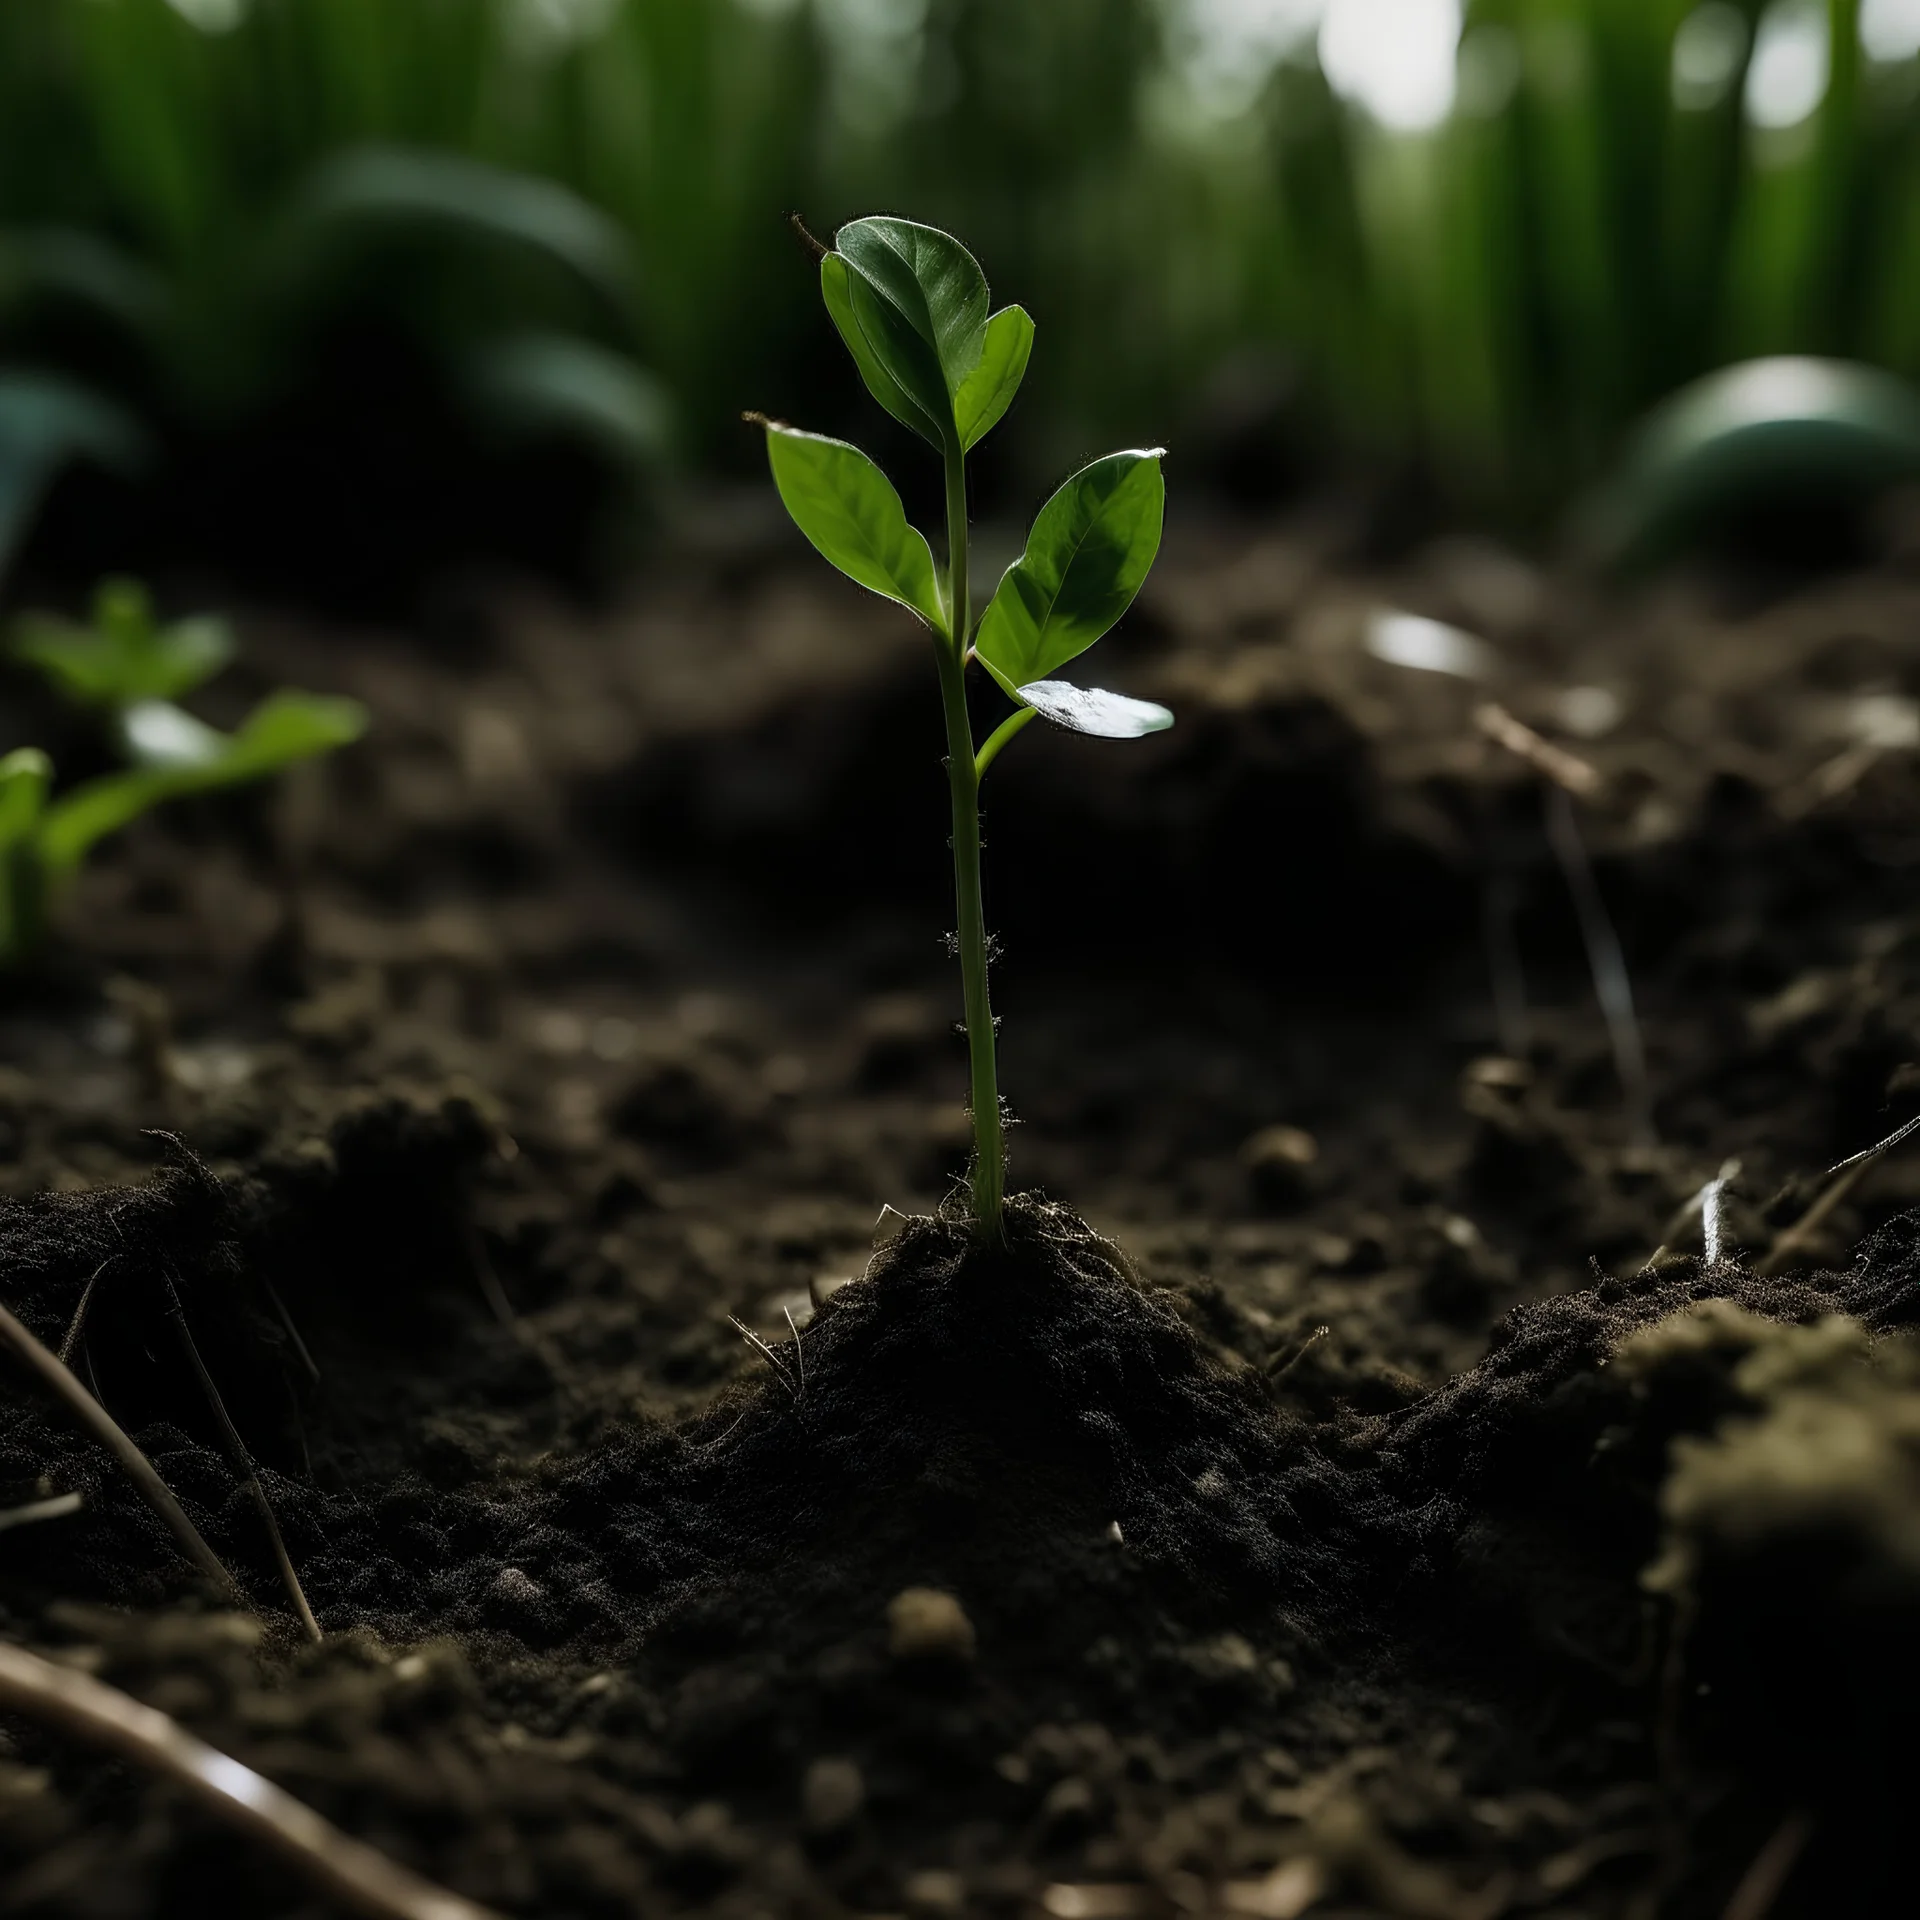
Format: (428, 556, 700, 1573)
(0, 580, 367, 966)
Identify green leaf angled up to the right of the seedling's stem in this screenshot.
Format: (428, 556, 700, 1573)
(973, 447, 1167, 699)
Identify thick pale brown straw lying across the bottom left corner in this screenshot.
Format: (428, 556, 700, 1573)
(0, 1645, 495, 1920)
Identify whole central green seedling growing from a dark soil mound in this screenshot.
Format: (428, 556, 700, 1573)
(747, 219, 1173, 1240)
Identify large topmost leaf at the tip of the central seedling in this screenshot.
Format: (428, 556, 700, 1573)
(833, 217, 989, 444)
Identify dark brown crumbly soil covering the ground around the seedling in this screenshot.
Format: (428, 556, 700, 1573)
(0, 503, 1920, 1920)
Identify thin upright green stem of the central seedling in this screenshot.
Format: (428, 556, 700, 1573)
(935, 447, 1006, 1240)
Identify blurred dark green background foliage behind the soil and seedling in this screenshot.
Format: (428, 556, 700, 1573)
(0, 0, 1920, 586)
